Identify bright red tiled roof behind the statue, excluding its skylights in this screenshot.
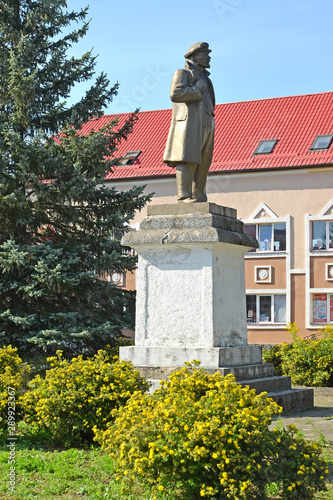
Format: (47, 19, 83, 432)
(78, 92, 333, 180)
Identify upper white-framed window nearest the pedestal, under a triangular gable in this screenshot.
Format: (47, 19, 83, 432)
(244, 222, 286, 252)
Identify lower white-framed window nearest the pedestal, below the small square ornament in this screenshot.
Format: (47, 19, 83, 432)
(246, 294, 286, 324)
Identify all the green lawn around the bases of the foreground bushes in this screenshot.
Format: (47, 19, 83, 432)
(0, 422, 333, 500)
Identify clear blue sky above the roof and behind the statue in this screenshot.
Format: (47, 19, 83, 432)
(68, 0, 333, 113)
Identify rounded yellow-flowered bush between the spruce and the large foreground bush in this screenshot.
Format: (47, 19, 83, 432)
(24, 350, 148, 445)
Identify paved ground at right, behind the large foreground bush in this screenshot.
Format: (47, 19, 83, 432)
(272, 387, 333, 444)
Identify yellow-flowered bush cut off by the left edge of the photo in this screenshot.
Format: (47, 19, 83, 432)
(0, 345, 30, 432)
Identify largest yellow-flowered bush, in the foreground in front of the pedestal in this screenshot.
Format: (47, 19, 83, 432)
(95, 365, 326, 500)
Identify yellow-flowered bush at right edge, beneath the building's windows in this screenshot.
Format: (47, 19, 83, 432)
(263, 323, 333, 387)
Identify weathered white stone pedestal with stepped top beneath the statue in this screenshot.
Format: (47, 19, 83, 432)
(120, 203, 313, 412)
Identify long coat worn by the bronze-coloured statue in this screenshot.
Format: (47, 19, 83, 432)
(163, 61, 215, 167)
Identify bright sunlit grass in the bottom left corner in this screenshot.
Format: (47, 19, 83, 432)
(0, 449, 121, 500)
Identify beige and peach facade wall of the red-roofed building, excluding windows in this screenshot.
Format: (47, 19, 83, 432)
(110, 167, 333, 343)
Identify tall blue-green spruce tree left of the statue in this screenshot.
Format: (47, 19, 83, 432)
(0, 0, 148, 355)
